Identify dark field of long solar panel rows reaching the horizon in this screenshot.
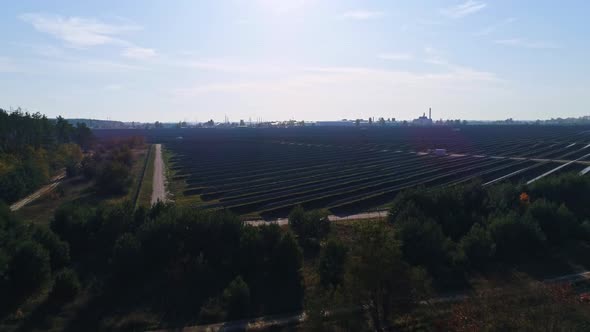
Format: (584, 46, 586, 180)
(93, 126, 590, 218)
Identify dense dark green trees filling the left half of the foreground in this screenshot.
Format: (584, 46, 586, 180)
(0, 202, 303, 330)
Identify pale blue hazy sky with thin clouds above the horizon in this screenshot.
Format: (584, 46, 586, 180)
(0, 0, 590, 122)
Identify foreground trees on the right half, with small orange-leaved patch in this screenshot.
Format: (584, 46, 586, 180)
(302, 173, 590, 331)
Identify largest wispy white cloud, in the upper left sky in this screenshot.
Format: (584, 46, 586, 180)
(19, 13, 141, 48)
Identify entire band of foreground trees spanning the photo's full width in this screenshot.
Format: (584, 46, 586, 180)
(0, 170, 590, 331)
